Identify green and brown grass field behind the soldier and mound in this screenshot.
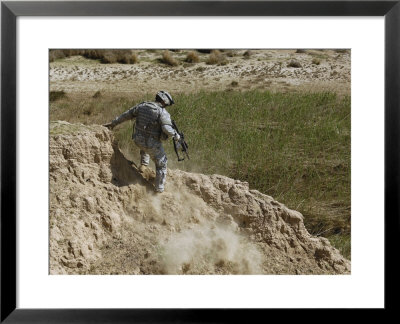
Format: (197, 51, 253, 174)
(50, 91, 351, 258)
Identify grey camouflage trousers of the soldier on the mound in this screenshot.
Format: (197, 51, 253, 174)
(134, 134, 167, 191)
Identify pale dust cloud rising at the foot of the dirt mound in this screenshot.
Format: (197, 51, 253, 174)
(162, 224, 262, 274)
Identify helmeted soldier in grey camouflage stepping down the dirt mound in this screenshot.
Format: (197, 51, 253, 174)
(103, 91, 180, 192)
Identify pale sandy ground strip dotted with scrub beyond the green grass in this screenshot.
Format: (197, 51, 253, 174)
(49, 50, 351, 95)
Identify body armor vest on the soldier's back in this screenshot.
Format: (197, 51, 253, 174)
(135, 102, 162, 139)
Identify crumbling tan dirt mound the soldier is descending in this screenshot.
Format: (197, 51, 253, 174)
(49, 122, 350, 274)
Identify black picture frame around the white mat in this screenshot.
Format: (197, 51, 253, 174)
(0, 0, 400, 323)
